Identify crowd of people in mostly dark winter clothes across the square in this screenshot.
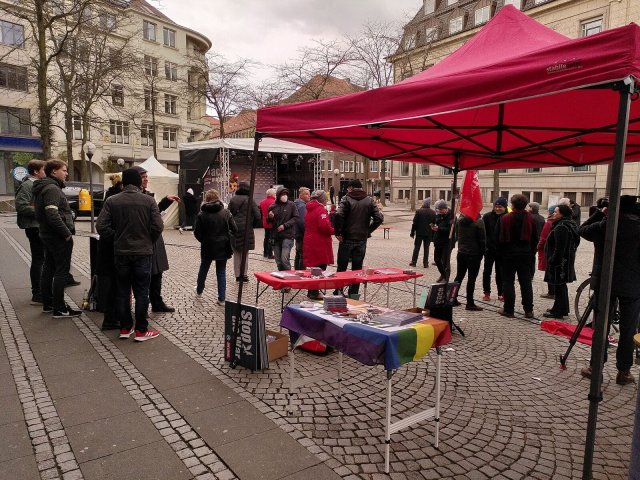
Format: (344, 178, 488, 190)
(16, 165, 640, 384)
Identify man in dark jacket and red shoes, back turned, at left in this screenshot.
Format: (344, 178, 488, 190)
(96, 168, 164, 342)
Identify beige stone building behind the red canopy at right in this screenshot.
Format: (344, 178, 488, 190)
(389, 0, 640, 207)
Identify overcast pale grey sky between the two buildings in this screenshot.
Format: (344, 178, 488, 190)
(157, 0, 422, 74)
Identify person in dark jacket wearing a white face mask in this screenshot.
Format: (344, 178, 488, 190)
(267, 187, 299, 271)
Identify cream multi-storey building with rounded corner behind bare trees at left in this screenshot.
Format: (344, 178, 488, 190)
(0, 0, 211, 194)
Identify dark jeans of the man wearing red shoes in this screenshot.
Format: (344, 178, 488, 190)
(114, 255, 151, 332)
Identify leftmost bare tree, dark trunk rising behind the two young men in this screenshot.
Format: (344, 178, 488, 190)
(0, 0, 106, 158)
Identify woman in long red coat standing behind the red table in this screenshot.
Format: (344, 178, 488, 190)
(303, 190, 334, 300)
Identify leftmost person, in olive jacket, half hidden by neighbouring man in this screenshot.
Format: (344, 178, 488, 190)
(16, 160, 46, 305)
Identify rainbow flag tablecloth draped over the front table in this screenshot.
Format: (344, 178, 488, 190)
(280, 305, 451, 370)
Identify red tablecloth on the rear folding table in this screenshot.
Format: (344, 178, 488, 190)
(255, 267, 423, 290)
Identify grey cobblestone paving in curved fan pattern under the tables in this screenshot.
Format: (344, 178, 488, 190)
(0, 210, 638, 480)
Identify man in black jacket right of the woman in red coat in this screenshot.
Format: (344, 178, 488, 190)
(334, 180, 384, 295)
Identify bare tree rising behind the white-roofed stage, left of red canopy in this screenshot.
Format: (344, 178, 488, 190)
(187, 52, 256, 138)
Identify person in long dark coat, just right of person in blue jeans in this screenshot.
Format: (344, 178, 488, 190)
(229, 182, 262, 282)
